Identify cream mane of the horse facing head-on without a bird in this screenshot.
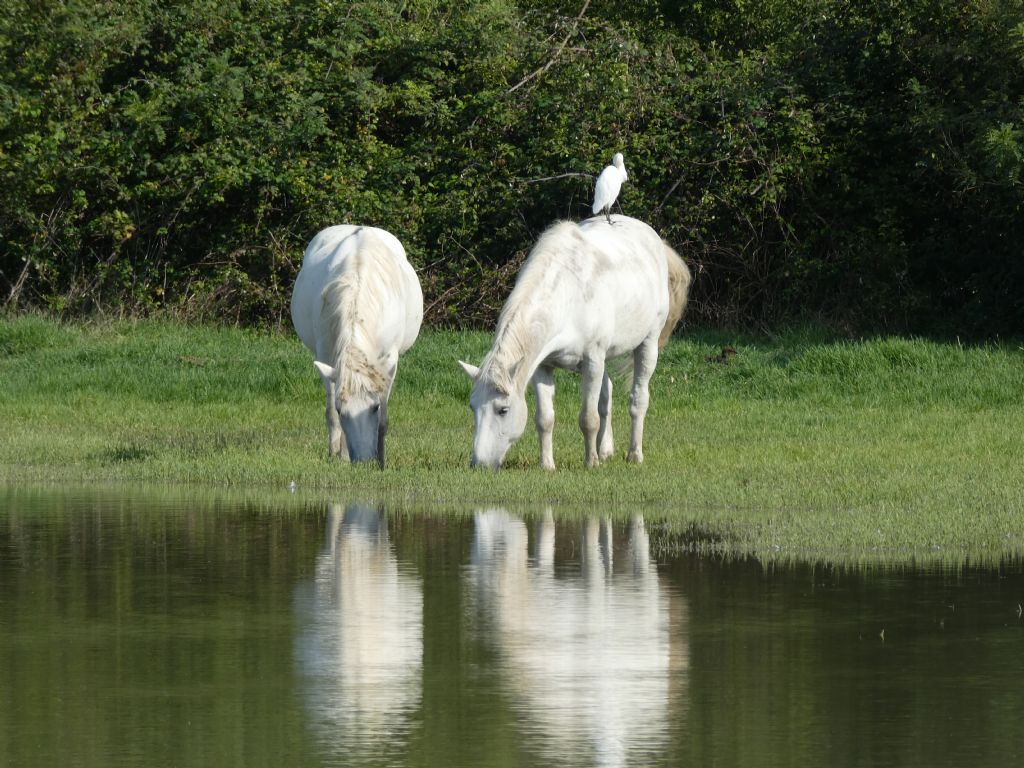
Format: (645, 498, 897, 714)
(321, 229, 397, 397)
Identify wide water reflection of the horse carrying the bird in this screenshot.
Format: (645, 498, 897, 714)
(469, 510, 688, 766)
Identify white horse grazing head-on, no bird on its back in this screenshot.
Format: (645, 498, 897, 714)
(292, 224, 423, 467)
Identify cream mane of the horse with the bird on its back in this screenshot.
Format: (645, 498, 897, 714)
(480, 221, 584, 395)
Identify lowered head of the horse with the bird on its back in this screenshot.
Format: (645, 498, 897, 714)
(459, 360, 526, 470)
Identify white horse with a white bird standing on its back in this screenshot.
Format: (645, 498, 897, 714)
(459, 216, 690, 469)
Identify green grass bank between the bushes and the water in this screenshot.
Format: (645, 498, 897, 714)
(0, 316, 1024, 559)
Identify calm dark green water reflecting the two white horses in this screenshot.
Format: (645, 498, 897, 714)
(0, 490, 1024, 767)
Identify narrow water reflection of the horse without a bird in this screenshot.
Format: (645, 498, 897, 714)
(296, 506, 423, 761)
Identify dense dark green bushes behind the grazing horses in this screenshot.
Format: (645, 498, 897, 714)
(0, 0, 1024, 334)
